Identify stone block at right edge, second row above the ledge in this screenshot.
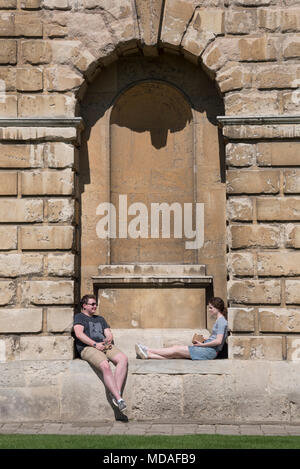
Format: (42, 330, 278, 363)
(258, 308, 300, 333)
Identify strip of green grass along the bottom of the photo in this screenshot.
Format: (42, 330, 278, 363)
(0, 435, 300, 449)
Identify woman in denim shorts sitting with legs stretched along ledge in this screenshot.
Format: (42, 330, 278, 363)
(135, 298, 228, 360)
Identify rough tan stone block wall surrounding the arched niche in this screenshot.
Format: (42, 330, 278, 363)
(0, 0, 300, 361)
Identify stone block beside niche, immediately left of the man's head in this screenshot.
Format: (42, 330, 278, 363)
(21, 280, 74, 305)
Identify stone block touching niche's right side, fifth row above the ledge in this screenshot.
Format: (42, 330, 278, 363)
(231, 224, 280, 249)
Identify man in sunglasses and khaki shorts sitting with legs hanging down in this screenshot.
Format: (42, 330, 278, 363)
(74, 295, 128, 411)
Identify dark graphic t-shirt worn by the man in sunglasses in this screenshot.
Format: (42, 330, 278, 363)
(74, 313, 109, 353)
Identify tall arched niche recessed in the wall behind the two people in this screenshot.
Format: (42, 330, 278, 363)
(80, 55, 226, 328)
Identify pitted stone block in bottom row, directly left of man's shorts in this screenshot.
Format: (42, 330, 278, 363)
(20, 336, 73, 360)
